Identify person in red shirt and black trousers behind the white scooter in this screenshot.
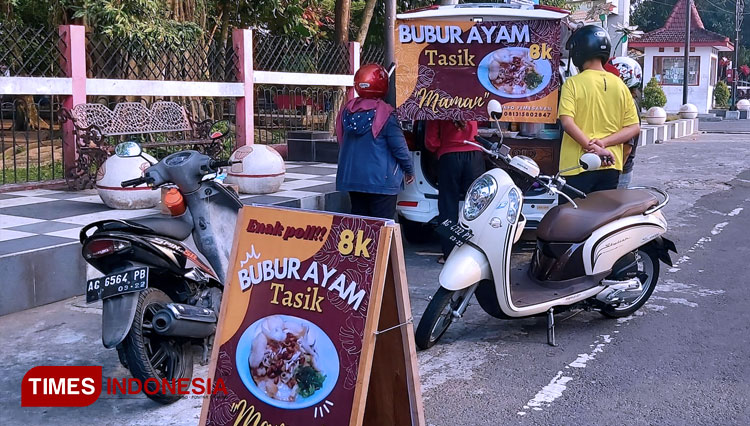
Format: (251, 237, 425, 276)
(425, 120, 485, 263)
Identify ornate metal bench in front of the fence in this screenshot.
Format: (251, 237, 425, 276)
(59, 101, 229, 190)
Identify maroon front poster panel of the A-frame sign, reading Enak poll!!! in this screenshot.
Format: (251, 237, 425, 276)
(203, 207, 387, 426)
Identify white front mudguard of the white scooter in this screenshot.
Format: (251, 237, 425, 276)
(440, 244, 492, 291)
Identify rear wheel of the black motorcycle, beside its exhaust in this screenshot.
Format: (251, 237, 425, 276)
(123, 288, 193, 404)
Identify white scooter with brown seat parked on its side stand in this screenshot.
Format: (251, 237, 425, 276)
(415, 102, 676, 349)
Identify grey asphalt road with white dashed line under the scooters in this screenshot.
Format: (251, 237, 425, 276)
(0, 131, 750, 425)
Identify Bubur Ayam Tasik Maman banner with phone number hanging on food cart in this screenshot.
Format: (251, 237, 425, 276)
(395, 19, 561, 123)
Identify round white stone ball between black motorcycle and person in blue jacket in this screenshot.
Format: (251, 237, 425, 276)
(226, 145, 286, 194)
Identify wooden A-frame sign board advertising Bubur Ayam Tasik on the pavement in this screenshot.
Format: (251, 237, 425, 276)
(200, 206, 424, 426)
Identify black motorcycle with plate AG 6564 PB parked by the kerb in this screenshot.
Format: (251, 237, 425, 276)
(80, 142, 242, 404)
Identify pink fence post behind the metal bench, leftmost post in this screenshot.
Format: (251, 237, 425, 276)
(58, 25, 86, 173)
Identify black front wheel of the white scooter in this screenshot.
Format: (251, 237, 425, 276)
(414, 287, 463, 350)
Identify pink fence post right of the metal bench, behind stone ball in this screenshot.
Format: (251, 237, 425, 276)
(232, 28, 255, 148)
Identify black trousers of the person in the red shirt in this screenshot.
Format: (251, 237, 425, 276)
(438, 151, 485, 257)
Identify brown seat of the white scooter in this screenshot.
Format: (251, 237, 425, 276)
(537, 189, 659, 243)
